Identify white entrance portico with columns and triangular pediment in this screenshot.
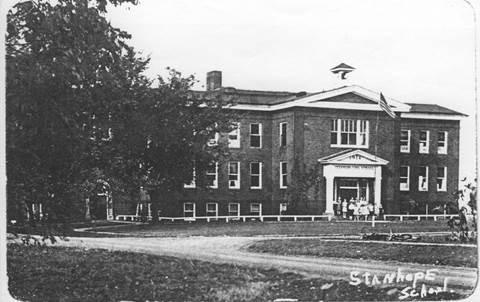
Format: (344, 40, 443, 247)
(318, 149, 388, 214)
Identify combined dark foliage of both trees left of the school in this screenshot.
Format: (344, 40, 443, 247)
(6, 0, 233, 221)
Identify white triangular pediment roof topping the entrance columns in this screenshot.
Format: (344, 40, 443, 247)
(318, 149, 388, 166)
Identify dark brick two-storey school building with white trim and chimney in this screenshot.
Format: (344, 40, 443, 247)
(119, 71, 465, 217)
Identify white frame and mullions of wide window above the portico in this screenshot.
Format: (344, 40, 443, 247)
(330, 119, 370, 149)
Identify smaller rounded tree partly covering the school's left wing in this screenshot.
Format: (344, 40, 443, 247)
(113, 69, 236, 220)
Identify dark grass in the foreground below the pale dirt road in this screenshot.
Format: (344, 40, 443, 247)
(7, 244, 464, 302)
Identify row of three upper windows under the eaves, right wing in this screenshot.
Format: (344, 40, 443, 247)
(400, 129, 448, 154)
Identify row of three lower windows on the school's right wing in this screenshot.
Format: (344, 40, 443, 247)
(400, 166, 447, 192)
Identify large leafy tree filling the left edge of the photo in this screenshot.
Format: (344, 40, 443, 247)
(6, 0, 150, 221)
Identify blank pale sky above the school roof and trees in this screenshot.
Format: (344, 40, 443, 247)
(107, 0, 476, 178)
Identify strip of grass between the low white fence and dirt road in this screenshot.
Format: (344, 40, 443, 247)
(84, 220, 456, 237)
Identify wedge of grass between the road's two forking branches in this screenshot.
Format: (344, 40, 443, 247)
(248, 239, 477, 267)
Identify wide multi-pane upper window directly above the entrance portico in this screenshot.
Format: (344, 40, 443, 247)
(330, 119, 369, 148)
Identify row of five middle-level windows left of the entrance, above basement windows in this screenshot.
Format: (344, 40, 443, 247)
(184, 161, 287, 189)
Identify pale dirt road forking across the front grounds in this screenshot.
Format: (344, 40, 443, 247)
(53, 236, 477, 292)
